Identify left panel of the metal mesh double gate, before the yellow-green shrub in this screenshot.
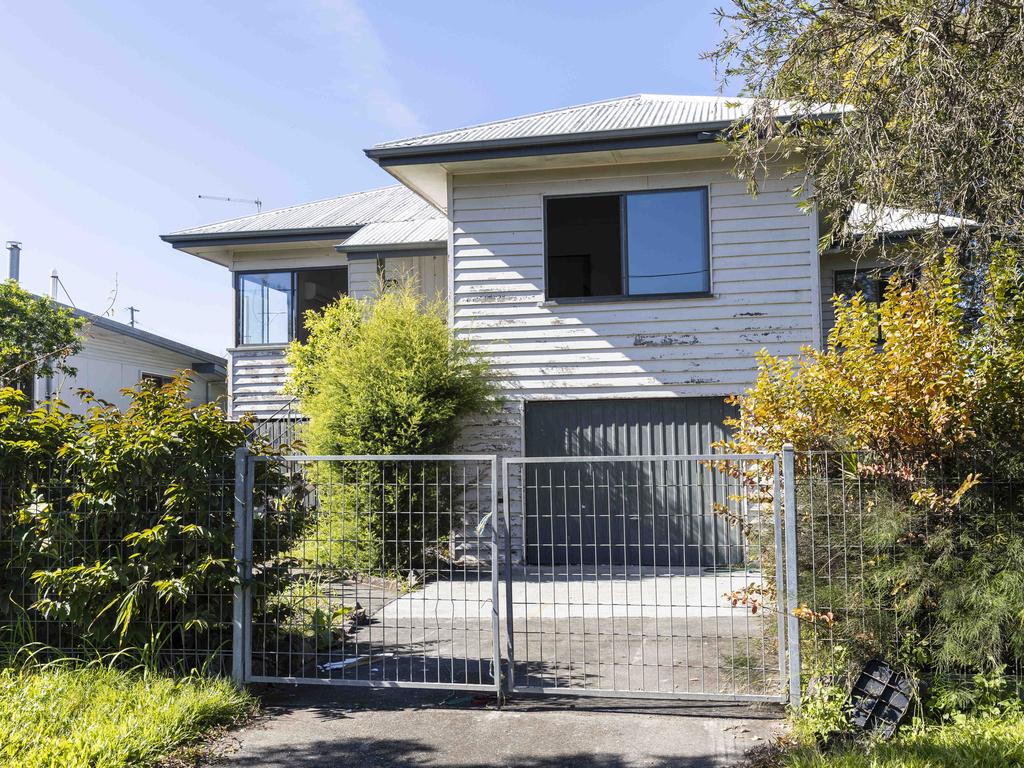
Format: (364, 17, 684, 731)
(247, 456, 500, 689)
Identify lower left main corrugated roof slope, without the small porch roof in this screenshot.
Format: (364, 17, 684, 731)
(166, 184, 439, 238)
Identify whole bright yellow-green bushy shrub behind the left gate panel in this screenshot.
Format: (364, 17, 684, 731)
(289, 281, 498, 573)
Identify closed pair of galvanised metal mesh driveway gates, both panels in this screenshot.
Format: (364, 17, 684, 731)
(234, 454, 786, 701)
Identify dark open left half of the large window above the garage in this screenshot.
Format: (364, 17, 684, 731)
(545, 195, 623, 298)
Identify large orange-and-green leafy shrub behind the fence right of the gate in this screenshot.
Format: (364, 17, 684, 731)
(730, 247, 1024, 692)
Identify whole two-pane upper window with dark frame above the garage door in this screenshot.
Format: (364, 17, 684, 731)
(544, 187, 711, 299)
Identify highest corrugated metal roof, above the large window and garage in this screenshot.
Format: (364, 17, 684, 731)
(374, 93, 826, 150)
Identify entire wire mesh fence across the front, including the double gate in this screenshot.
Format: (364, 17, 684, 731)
(22, 436, 1007, 700)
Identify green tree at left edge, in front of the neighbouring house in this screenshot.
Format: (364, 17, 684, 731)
(0, 280, 85, 388)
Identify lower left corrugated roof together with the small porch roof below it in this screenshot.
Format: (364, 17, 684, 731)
(162, 184, 447, 247)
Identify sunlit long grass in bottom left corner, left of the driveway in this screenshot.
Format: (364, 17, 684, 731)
(0, 667, 254, 768)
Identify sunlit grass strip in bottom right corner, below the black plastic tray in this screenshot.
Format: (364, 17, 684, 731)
(774, 717, 1024, 768)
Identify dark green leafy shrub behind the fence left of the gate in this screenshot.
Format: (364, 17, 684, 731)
(0, 377, 305, 664)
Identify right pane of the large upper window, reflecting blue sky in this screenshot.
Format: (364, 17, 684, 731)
(626, 189, 711, 295)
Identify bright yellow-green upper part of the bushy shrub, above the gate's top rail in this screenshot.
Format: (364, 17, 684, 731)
(289, 282, 498, 454)
